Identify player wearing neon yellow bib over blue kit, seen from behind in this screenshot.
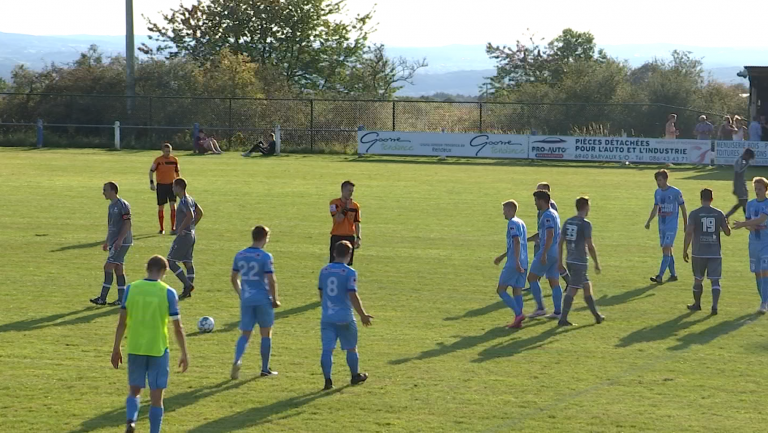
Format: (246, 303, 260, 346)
(112, 255, 189, 433)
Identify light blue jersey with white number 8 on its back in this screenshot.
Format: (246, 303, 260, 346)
(317, 263, 357, 323)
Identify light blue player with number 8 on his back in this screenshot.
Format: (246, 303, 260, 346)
(318, 241, 373, 390)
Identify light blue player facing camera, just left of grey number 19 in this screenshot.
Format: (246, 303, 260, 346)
(645, 170, 688, 284)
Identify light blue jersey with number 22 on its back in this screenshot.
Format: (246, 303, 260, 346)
(232, 247, 275, 306)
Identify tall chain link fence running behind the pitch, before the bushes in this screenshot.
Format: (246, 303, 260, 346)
(0, 93, 732, 153)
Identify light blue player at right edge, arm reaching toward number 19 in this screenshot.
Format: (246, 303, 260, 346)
(733, 177, 768, 314)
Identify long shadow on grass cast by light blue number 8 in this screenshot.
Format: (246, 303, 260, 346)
(189, 385, 344, 433)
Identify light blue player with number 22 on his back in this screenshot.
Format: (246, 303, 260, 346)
(231, 226, 280, 380)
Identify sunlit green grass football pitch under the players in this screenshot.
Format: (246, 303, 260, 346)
(0, 149, 768, 432)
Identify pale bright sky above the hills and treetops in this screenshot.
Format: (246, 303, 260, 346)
(0, 0, 768, 47)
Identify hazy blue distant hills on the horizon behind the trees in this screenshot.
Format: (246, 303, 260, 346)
(0, 32, 756, 96)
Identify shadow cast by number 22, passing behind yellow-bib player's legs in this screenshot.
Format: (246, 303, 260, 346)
(72, 375, 260, 433)
